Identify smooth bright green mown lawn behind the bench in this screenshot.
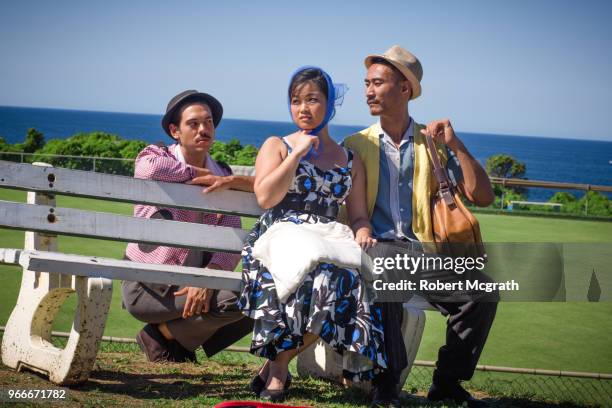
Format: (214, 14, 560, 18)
(0, 189, 612, 373)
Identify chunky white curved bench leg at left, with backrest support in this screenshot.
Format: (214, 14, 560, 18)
(2, 180, 112, 385)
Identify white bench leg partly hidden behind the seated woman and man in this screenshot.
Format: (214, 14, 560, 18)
(297, 305, 425, 390)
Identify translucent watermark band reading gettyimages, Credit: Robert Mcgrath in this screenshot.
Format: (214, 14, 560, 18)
(362, 242, 612, 302)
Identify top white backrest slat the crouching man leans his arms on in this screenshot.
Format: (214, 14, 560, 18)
(0, 160, 263, 217)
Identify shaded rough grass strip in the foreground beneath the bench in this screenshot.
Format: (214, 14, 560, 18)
(5, 338, 612, 408)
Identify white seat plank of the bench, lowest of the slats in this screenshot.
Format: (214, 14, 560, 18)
(0, 249, 242, 292)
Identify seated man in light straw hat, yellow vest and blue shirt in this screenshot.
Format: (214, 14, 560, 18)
(344, 45, 497, 407)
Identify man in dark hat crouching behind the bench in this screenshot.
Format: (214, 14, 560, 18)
(122, 90, 253, 362)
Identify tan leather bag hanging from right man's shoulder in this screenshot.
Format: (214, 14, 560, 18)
(425, 135, 486, 258)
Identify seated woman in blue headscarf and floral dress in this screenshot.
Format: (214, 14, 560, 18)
(239, 67, 386, 400)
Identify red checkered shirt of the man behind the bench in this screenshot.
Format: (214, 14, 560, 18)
(126, 144, 242, 271)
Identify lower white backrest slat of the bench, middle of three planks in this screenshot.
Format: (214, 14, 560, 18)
(0, 200, 248, 253)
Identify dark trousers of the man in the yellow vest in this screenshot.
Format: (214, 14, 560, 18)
(368, 241, 499, 384)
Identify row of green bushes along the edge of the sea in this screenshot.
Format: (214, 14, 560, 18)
(0, 129, 612, 216)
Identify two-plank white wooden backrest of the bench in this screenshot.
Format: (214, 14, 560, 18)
(0, 161, 262, 253)
